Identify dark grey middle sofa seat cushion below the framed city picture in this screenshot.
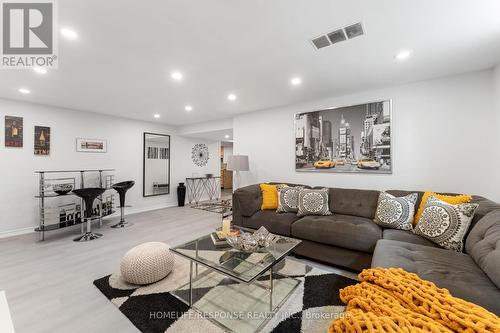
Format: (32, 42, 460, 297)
(292, 214, 382, 253)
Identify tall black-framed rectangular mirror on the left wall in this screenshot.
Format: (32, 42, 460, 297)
(142, 132, 170, 197)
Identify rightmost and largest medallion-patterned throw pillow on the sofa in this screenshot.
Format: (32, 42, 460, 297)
(414, 196, 479, 252)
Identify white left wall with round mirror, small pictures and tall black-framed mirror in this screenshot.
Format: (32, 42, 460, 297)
(0, 99, 220, 235)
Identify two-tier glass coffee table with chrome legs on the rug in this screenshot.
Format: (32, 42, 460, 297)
(171, 227, 301, 332)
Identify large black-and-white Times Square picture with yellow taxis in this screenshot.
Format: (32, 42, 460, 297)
(295, 100, 392, 174)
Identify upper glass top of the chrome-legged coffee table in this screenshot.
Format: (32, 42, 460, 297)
(171, 227, 301, 283)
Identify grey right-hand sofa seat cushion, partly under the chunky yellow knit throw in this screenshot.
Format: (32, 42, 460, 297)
(372, 239, 500, 314)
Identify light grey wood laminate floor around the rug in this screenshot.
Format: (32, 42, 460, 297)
(0, 207, 354, 333)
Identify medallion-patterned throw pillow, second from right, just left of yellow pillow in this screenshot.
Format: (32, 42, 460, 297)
(373, 192, 418, 230)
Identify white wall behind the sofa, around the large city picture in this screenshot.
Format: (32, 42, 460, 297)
(234, 71, 500, 201)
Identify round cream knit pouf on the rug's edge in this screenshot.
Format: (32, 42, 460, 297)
(120, 242, 174, 285)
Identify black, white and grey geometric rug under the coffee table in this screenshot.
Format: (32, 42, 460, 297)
(94, 257, 357, 333)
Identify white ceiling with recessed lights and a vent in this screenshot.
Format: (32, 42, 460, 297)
(0, 0, 500, 125)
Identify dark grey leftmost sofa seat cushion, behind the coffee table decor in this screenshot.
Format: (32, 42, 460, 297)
(242, 210, 299, 236)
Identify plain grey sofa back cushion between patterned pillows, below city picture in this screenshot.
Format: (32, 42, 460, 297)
(330, 188, 380, 219)
